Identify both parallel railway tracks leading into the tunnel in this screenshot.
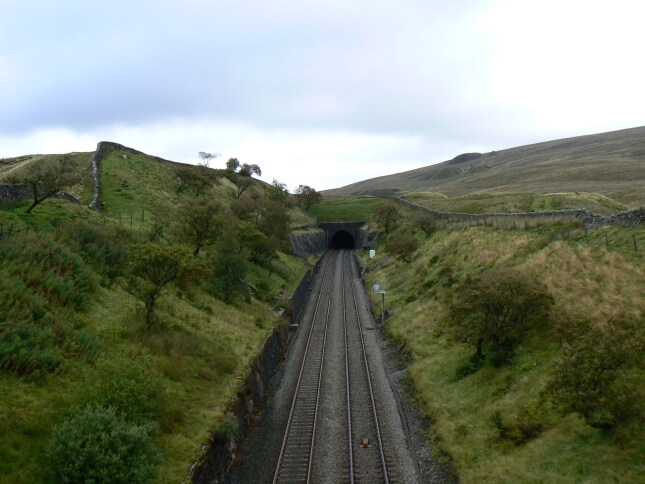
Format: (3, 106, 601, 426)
(273, 251, 398, 483)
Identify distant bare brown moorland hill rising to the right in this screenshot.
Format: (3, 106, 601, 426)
(323, 127, 645, 206)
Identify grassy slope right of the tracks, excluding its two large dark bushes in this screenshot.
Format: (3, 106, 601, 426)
(363, 218, 645, 482)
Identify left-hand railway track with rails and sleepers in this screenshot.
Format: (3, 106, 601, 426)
(273, 251, 333, 483)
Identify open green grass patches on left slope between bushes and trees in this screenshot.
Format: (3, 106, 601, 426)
(0, 147, 310, 483)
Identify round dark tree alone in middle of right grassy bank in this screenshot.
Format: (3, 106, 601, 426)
(449, 268, 553, 362)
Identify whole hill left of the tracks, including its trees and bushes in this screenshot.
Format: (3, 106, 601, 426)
(0, 144, 309, 482)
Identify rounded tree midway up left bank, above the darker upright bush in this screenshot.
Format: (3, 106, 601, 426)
(178, 200, 226, 257)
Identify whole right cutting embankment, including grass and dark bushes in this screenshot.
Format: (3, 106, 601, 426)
(364, 219, 645, 482)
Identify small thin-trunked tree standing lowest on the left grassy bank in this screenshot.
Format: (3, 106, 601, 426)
(128, 243, 186, 327)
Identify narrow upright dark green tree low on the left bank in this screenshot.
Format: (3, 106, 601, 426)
(213, 230, 247, 304)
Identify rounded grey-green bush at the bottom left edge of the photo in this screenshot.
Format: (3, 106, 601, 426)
(48, 406, 162, 483)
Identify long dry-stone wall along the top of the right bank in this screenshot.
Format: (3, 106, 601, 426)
(392, 197, 645, 229)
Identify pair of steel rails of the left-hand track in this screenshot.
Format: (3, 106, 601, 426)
(273, 251, 335, 484)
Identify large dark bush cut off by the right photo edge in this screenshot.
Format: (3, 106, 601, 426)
(547, 316, 645, 427)
